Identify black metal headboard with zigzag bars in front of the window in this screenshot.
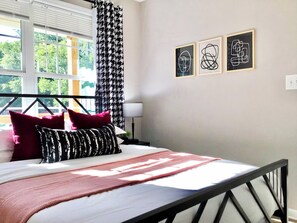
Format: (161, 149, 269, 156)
(0, 94, 97, 115)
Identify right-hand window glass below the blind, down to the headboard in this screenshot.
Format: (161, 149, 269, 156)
(34, 28, 95, 112)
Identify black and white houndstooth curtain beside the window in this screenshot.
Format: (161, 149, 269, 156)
(94, 0, 125, 128)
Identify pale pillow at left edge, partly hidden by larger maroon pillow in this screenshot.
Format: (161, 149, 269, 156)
(0, 129, 14, 163)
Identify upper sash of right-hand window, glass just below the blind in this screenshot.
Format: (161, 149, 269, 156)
(34, 28, 94, 78)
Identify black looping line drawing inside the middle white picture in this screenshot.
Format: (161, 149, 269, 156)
(200, 43, 220, 70)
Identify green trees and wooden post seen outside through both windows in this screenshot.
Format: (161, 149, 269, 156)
(0, 17, 95, 121)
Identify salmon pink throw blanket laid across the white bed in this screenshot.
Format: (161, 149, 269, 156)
(0, 151, 217, 223)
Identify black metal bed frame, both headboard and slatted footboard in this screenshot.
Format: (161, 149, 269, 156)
(0, 94, 288, 223)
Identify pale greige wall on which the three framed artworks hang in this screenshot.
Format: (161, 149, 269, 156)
(138, 0, 297, 210)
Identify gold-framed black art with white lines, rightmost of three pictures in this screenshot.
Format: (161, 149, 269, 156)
(226, 29, 255, 72)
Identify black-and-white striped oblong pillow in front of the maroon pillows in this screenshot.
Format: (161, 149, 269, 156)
(36, 124, 122, 163)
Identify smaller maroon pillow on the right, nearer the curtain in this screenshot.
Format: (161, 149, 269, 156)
(68, 109, 111, 130)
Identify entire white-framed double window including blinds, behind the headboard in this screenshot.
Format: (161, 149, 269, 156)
(0, 0, 95, 118)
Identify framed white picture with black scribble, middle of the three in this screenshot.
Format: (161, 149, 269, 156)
(198, 36, 223, 75)
